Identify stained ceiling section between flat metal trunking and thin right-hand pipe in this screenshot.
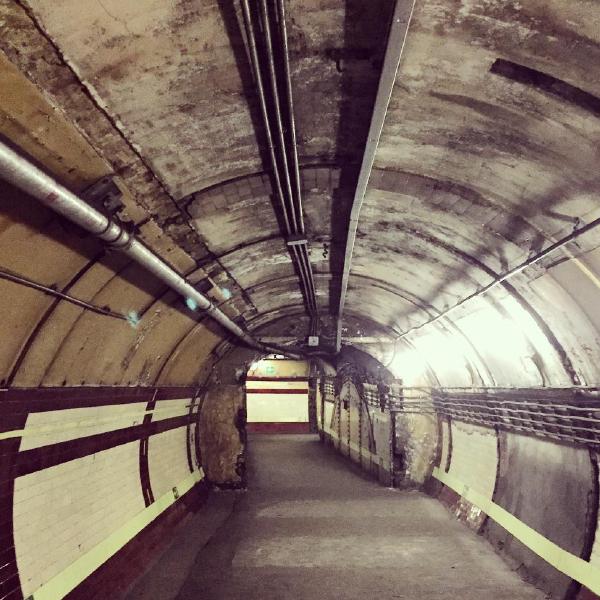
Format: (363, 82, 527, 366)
(350, 0, 600, 332)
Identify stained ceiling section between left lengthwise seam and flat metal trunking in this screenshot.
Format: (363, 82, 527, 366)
(5, 0, 393, 338)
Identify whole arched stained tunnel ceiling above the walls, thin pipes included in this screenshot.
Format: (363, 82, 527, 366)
(0, 0, 600, 385)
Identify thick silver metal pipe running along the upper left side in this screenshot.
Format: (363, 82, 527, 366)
(0, 142, 265, 350)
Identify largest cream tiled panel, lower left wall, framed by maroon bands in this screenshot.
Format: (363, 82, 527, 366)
(13, 441, 144, 596)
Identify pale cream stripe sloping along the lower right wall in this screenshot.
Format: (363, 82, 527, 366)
(433, 467, 600, 594)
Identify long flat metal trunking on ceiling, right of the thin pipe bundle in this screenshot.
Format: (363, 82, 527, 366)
(336, 0, 415, 351)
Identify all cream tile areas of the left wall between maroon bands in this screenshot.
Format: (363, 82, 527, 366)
(13, 398, 198, 597)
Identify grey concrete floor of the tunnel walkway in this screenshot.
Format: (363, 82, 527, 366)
(128, 435, 544, 600)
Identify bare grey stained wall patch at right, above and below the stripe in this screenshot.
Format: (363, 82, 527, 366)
(486, 434, 597, 598)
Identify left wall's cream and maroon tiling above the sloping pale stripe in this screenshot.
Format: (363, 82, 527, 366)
(0, 387, 201, 600)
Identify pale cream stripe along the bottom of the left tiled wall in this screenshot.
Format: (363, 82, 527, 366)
(31, 469, 204, 600)
